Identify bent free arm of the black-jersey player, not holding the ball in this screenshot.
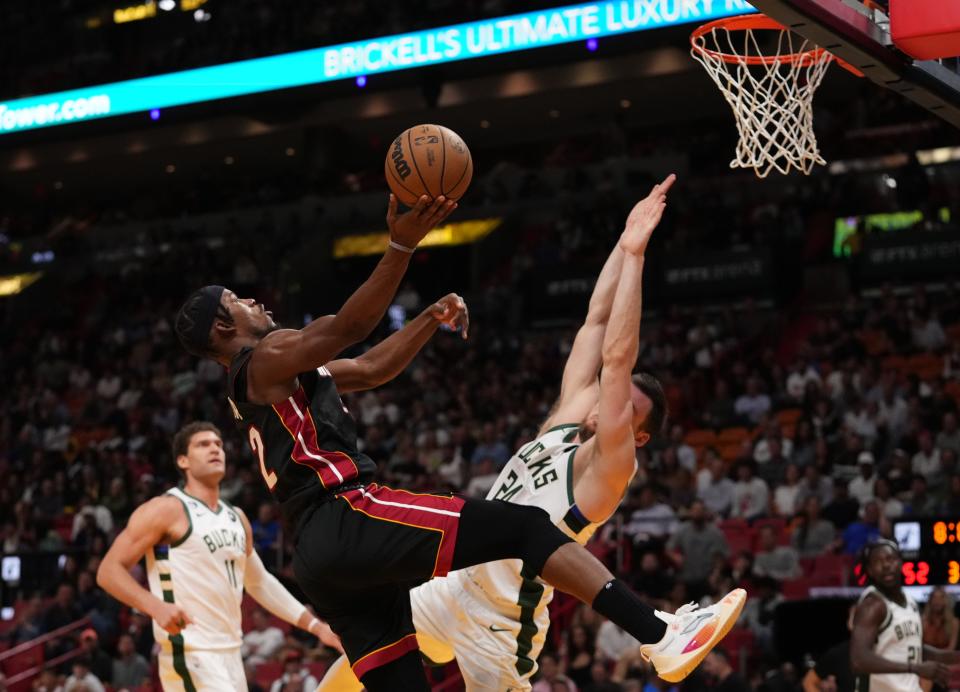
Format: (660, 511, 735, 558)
(326, 293, 470, 393)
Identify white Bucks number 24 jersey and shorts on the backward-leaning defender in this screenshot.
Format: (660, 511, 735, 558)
(410, 425, 599, 692)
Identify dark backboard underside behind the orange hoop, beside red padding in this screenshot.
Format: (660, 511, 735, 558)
(750, 0, 960, 128)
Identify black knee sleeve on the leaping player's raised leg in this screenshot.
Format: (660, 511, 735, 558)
(453, 500, 572, 574)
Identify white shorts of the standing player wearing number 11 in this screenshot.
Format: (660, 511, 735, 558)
(157, 646, 247, 692)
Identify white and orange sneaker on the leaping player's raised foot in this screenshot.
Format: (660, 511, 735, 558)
(640, 589, 747, 682)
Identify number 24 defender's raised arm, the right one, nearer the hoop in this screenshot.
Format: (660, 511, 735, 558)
(574, 176, 673, 522)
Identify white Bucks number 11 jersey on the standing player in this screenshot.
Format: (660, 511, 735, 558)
(147, 488, 247, 662)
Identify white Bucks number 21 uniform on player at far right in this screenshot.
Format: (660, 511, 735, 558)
(856, 586, 923, 692)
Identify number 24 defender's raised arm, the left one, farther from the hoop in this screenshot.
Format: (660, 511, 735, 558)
(539, 175, 676, 435)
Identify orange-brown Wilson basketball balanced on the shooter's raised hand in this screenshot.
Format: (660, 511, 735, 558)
(384, 125, 473, 207)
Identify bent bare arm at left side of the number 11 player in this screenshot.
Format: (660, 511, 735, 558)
(97, 497, 193, 634)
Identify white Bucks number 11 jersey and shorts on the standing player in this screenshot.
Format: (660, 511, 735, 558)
(147, 488, 247, 692)
